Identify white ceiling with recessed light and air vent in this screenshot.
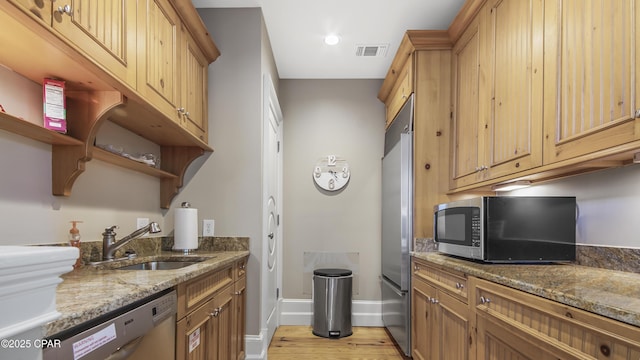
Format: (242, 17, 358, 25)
(192, 0, 464, 79)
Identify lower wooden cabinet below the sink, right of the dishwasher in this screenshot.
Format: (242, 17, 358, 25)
(176, 260, 246, 360)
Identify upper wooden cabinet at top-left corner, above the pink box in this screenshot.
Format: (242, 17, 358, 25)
(8, 0, 136, 87)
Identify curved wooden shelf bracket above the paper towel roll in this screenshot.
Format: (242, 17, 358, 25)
(160, 146, 204, 209)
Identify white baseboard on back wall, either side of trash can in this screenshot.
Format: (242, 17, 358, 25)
(280, 299, 383, 326)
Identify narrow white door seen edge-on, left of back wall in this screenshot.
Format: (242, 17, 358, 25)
(261, 75, 282, 344)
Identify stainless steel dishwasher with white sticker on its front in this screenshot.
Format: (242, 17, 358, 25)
(43, 290, 177, 360)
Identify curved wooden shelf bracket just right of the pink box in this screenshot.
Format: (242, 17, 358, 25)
(51, 91, 127, 196)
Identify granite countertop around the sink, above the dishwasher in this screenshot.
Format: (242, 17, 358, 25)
(43, 250, 249, 337)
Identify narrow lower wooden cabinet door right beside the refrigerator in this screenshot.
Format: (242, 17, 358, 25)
(411, 279, 438, 360)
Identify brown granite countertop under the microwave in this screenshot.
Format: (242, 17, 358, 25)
(411, 252, 640, 326)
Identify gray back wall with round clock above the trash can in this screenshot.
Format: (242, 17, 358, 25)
(280, 79, 385, 300)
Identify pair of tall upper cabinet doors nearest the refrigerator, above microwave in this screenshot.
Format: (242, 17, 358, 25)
(452, 0, 543, 188)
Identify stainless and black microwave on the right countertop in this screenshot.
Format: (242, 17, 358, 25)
(434, 196, 577, 263)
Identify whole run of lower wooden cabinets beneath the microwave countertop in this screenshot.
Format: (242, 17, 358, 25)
(411, 258, 640, 360)
